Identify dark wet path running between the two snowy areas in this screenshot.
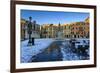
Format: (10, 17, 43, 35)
(32, 41, 62, 62)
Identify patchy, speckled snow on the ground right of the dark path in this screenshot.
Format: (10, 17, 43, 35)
(61, 39, 89, 61)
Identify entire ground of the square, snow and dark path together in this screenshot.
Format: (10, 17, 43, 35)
(21, 38, 89, 63)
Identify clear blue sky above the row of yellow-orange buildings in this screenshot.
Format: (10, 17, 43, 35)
(21, 10, 89, 25)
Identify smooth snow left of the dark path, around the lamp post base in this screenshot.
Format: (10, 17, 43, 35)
(21, 39, 54, 63)
